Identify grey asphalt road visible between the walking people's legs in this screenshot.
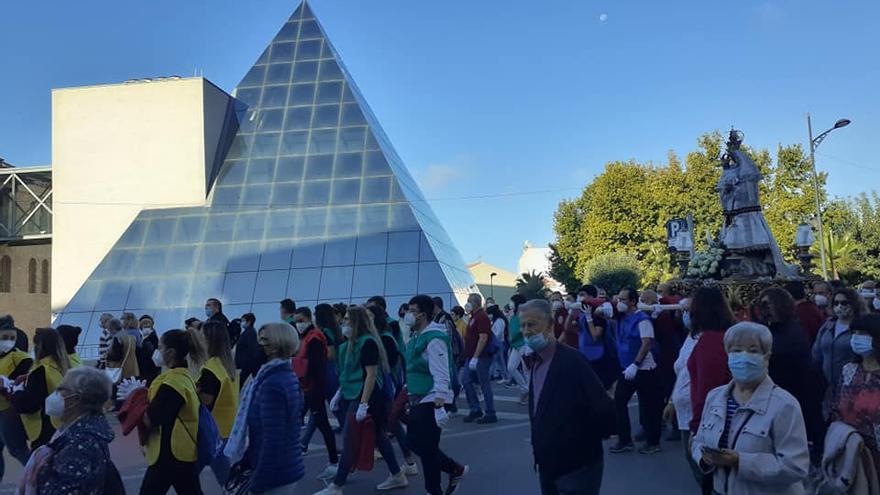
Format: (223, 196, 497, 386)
(0, 387, 696, 495)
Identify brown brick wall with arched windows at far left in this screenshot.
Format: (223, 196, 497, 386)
(0, 243, 52, 334)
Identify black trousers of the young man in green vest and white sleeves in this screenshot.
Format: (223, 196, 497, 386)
(406, 403, 459, 495)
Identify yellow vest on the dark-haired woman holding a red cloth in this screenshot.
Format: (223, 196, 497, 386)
(146, 368, 199, 466)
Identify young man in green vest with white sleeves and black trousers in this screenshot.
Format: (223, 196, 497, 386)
(404, 295, 468, 495)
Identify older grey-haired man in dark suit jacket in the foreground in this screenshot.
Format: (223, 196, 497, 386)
(519, 299, 614, 495)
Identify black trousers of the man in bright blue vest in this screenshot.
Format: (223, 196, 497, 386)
(614, 368, 663, 445)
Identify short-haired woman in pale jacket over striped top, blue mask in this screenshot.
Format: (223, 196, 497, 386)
(691, 322, 810, 495)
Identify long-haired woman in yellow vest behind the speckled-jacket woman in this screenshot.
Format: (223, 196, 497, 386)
(12, 328, 70, 450)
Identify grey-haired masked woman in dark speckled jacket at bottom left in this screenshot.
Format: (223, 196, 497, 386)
(22, 367, 124, 495)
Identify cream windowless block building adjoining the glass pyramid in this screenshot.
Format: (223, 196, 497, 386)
(52, 78, 229, 311)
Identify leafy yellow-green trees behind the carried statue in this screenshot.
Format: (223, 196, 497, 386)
(552, 131, 864, 287)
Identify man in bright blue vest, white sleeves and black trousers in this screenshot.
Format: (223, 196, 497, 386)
(610, 288, 663, 454)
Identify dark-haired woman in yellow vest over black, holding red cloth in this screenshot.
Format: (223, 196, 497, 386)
(140, 330, 202, 495)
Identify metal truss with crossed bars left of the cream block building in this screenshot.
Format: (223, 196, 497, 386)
(0, 167, 52, 242)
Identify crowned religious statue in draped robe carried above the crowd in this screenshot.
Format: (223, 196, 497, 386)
(716, 130, 797, 278)
